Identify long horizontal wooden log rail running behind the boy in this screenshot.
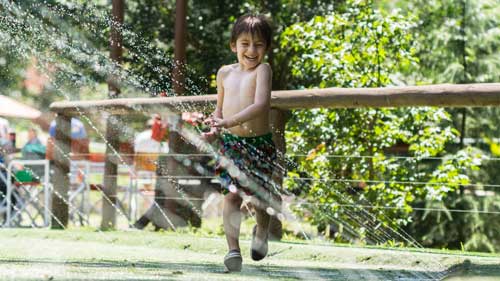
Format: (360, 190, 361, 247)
(50, 83, 500, 115)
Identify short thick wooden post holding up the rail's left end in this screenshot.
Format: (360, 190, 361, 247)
(51, 114, 71, 229)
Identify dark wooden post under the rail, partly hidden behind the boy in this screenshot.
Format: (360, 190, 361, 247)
(269, 109, 289, 240)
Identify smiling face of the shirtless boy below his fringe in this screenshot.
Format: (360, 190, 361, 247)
(231, 33, 267, 70)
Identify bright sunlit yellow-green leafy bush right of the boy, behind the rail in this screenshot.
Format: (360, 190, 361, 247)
(281, 1, 484, 243)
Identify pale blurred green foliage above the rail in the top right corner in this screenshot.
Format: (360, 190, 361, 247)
(403, 0, 500, 83)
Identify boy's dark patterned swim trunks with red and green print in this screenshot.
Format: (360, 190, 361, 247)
(215, 133, 280, 201)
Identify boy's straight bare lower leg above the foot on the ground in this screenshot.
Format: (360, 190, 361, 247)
(222, 192, 243, 251)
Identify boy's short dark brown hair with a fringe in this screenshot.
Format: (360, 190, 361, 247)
(231, 14, 272, 48)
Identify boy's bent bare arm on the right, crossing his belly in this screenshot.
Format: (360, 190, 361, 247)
(216, 64, 272, 128)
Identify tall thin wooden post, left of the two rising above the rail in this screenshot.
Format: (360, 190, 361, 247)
(101, 0, 124, 229)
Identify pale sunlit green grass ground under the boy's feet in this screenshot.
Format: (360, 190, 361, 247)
(0, 229, 500, 281)
